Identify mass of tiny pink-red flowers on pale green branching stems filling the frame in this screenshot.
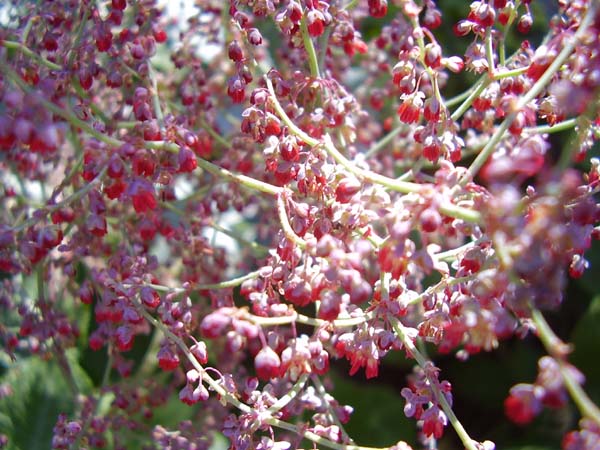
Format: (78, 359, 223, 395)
(0, 0, 600, 450)
